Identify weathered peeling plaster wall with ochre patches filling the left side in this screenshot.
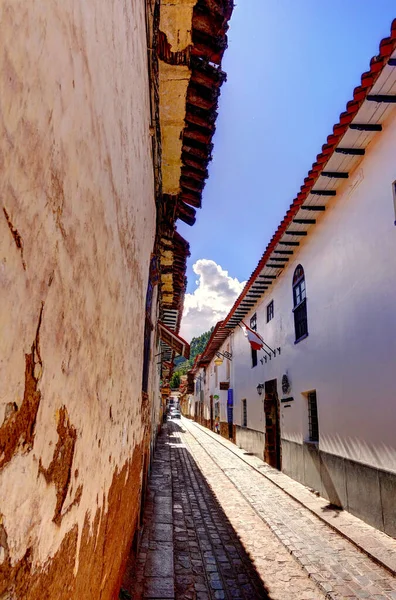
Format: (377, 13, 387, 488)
(0, 0, 155, 600)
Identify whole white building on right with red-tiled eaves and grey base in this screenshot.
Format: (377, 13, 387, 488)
(193, 38, 396, 537)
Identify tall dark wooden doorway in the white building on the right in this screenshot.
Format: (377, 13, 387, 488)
(264, 379, 282, 471)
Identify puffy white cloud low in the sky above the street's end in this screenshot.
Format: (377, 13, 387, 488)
(180, 258, 246, 341)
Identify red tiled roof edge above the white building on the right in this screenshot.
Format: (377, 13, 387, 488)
(223, 19, 396, 325)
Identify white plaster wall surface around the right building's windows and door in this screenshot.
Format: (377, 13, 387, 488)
(232, 106, 396, 471)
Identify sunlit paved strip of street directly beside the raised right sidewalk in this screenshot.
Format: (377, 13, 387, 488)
(183, 420, 396, 600)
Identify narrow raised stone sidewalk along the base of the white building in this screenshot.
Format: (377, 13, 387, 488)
(186, 419, 396, 576)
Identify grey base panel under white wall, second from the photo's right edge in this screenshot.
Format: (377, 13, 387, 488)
(345, 460, 384, 531)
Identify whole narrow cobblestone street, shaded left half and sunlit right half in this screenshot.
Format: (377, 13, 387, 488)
(120, 419, 396, 600)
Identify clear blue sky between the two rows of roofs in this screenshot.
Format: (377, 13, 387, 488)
(178, 0, 396, 342)
